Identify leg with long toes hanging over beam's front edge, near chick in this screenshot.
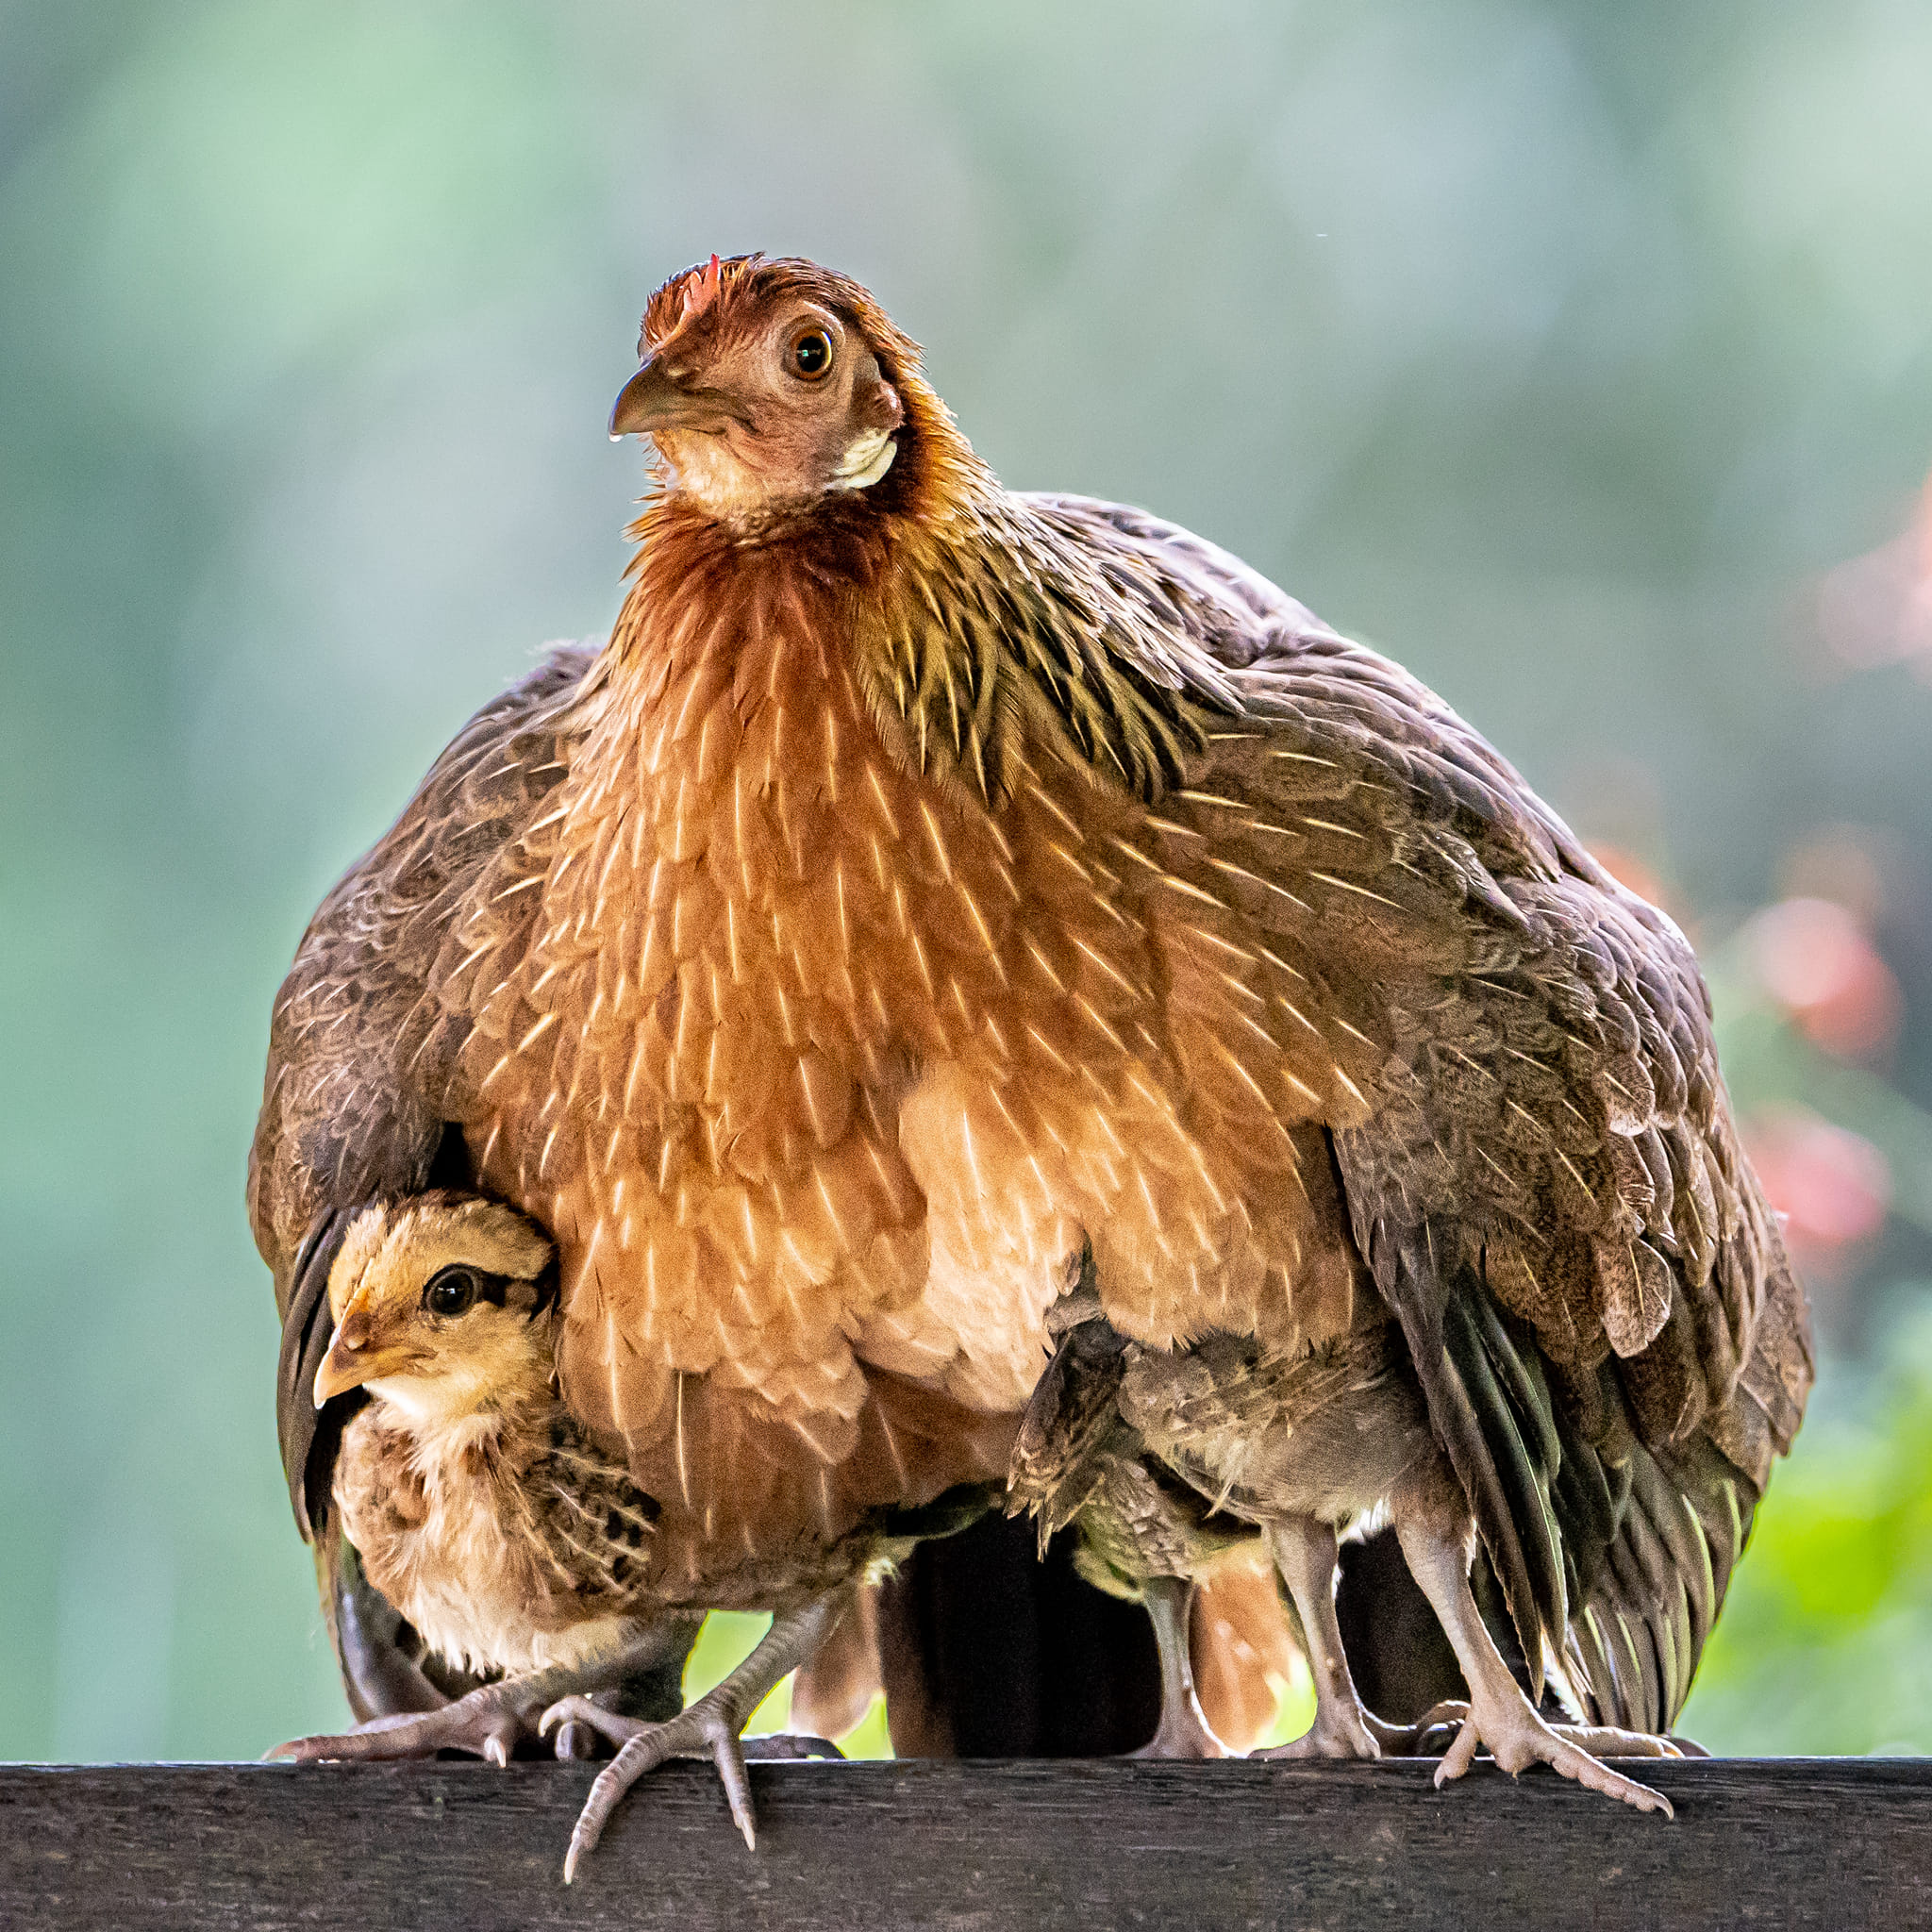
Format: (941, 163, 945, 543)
(541, 1591, 852, 1886)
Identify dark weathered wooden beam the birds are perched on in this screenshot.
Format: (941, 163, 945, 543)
(0, 1758, 1932, 1932)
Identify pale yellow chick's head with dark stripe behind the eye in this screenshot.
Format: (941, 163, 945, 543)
(315, 1191, 557, 1420)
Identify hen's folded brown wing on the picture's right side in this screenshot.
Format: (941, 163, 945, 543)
(1034, 498, 1810, 1683)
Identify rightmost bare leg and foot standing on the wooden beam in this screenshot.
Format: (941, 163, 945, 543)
(1395, 1513, 1677, 1818)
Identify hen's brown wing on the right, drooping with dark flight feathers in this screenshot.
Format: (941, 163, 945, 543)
(1042, 507, 1808, 1727)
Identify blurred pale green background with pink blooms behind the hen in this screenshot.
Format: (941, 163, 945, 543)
(0, 0, 1932, 1758)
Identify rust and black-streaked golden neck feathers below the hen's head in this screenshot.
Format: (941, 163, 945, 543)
(612, 355, 1237, 808)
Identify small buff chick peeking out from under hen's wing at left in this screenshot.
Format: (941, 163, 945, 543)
(275, 1191, 833, 1868)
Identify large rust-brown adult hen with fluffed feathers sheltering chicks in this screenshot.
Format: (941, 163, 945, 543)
(253, 257, 1810, 1831)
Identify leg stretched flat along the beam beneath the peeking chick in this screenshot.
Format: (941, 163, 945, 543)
(269, 1617, 703, 1764)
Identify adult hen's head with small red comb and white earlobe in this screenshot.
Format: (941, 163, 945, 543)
(610, 255, 937, 522)
